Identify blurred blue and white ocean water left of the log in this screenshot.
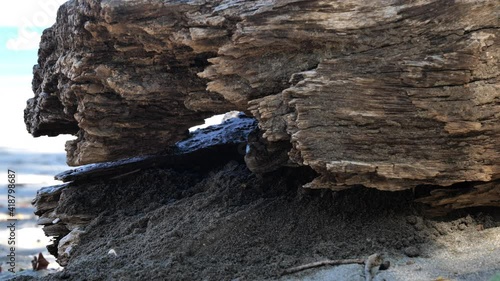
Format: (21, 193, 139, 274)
(0, 147, 69, 280)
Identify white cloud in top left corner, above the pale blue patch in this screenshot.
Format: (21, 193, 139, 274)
(0, 0, 66, 27)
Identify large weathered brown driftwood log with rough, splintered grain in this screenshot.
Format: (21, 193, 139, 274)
(25, 0, 500, 208)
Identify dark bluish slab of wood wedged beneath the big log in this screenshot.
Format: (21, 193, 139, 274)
(55, 115, 257, 182)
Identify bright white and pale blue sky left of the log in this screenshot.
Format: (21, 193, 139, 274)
(0, 0, 72, 153)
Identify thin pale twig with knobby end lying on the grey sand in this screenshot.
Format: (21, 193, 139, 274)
(281, 254, 384, 281)
